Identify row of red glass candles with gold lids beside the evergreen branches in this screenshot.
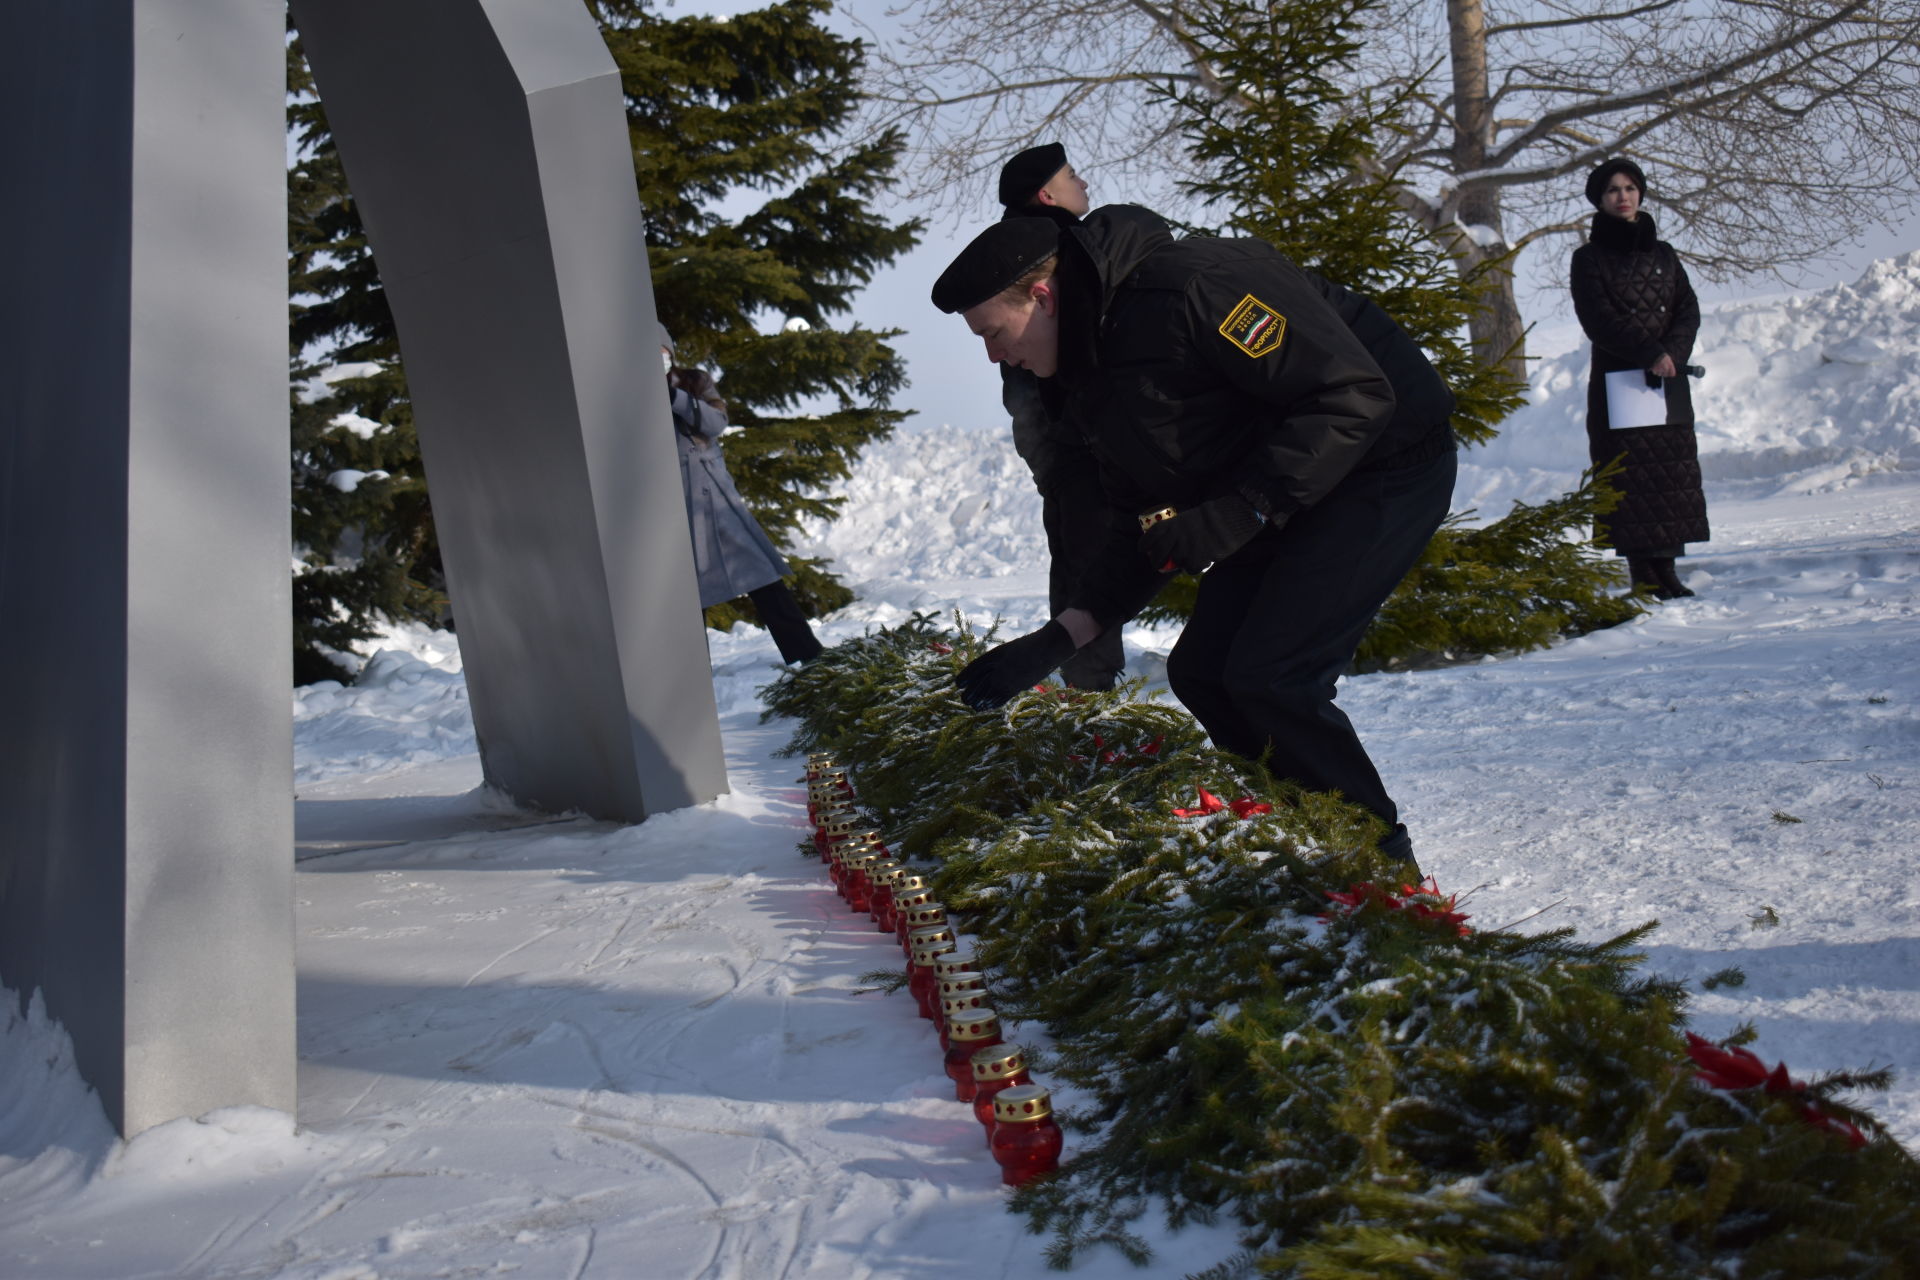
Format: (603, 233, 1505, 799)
(806, 752, 1062, 1186)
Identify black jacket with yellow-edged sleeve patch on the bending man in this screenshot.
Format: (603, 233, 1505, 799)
(1041, 205, 1453, 626)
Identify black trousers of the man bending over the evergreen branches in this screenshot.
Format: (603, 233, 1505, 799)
(1167, 453, 1455, 825)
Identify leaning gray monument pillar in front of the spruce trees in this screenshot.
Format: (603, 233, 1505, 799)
(292, 0, 726, 821)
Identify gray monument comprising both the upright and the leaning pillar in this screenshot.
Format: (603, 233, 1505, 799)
(0, 0, 726, 1134)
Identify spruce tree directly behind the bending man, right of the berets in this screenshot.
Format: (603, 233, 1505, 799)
(1121, 0, 1640, 670)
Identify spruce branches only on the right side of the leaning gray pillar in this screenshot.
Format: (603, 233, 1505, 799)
(589, 0, 920, 628)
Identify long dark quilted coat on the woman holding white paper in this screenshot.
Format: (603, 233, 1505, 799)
(1572, 211, 1711, 557)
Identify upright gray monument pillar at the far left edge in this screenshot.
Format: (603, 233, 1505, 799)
(0, 0, 294, 1134)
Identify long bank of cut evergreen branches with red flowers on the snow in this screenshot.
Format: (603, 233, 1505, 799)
(766, 614, 1920, 1280)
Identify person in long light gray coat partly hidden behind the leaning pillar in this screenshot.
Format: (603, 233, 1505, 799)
(660, 330, 822, 664)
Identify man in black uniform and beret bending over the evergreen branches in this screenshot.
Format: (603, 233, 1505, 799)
(933, 205, 1455, 858)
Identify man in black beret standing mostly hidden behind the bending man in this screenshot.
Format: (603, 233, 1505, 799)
(998, 142, 1127, 689)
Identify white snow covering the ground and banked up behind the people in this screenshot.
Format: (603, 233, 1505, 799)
(0, 255, 1920, 1280)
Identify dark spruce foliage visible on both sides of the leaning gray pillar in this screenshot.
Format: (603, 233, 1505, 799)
(288, 0, 920, 681)
